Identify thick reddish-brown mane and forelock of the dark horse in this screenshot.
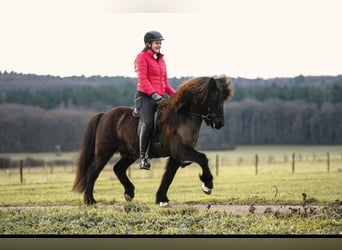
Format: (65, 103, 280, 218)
(160, 75, 234, 137)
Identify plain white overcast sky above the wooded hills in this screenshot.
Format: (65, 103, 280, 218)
(0, 0, 342, 78)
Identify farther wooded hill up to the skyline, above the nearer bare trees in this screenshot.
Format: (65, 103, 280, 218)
(0, 71, 342, 111)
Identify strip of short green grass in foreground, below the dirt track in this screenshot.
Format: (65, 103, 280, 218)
(0, 203, 342, 235)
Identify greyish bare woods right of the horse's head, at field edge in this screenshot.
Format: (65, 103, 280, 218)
(199, 99, 342, 149)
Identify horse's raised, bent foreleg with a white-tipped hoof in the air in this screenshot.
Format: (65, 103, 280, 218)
(177, 145, 214, 194)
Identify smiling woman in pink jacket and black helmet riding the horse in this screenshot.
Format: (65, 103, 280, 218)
(133, 31, 176, 170)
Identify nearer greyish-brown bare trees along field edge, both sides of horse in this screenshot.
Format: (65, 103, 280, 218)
(0, 99, 342, 152)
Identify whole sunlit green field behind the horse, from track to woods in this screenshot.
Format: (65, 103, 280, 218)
(0, 146, 342, 206)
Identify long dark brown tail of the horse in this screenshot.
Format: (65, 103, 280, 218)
(72, 113, 104, 192)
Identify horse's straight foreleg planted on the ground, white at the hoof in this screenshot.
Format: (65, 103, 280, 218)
(156, 157, 179, 207)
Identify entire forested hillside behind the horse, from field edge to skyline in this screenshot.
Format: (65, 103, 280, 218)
(0, 71, 342, 152)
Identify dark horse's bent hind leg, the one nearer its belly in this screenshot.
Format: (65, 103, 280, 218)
(113, 158, 136, 201)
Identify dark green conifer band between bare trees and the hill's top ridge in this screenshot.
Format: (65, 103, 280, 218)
(0, 81, 342, 111)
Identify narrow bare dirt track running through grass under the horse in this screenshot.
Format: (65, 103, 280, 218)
(0, 204, 323, 214)
